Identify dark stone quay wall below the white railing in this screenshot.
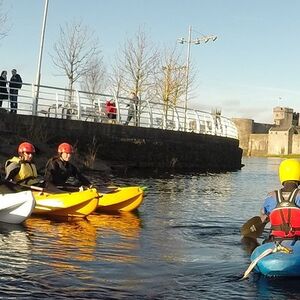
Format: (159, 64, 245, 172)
(0, 113, 242, 172)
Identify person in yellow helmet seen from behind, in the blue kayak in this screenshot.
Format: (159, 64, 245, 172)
(261, 159, 300, 239)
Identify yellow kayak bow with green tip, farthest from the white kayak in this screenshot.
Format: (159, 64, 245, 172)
(96, 186, 144, 212)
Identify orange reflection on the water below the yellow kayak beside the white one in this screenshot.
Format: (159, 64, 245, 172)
(25, 218, 96, 269)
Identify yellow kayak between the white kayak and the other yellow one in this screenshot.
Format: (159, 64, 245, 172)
(33, 188, 99, 218)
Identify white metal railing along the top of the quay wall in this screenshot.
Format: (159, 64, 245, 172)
(2, 83, 238, 139)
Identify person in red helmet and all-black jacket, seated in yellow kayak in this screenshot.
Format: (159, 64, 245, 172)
(44, 143, 91, 189)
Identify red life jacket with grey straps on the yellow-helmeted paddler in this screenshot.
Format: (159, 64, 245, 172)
(269, 189, 300, 238)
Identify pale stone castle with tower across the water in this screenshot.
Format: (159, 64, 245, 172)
(233, 107, 300, 156)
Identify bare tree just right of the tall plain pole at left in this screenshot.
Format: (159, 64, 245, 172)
(52, 21, 99, 102)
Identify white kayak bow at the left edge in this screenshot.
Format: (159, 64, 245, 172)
(0, 191, 35, 224)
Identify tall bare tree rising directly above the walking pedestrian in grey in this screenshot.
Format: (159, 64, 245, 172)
(115, 29, 158, 125)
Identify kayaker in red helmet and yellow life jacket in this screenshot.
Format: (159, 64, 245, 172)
(5, 142, 43, 185)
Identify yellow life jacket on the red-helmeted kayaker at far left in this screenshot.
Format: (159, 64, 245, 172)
(5, 157, 39, 185)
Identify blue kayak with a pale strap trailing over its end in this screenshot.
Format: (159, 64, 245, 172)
(251, 239, 300, 277)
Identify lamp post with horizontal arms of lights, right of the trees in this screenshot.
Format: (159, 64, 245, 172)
(178, 26, 217, 131)
